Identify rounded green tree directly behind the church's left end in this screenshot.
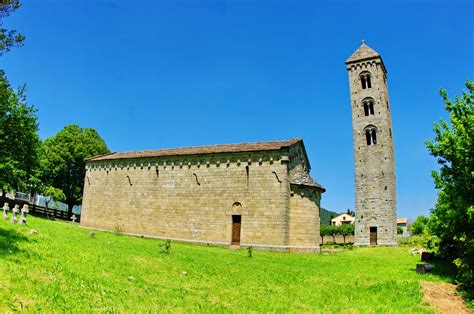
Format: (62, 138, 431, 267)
(43, 124, 109, 216)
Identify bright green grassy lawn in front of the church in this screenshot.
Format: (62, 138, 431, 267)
(0, 217, 450, 313)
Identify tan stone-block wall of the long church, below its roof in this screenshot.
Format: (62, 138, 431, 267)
(81, 147, 319, 251)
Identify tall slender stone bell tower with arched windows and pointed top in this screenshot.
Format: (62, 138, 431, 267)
(346, 44, 397, 245)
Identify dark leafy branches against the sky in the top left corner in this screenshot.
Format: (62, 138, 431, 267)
(0, 0, 25, 56)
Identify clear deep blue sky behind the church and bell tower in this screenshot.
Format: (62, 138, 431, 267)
(0, 0, 474, 218)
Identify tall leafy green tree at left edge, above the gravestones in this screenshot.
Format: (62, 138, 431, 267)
(0, 70, 41, 195)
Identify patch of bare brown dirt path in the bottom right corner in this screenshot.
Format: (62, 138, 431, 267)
(421, 281, 470, 314)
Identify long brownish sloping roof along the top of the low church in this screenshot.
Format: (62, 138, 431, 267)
(86, 138, 303, 161)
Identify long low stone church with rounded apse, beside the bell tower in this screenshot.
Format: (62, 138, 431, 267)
(81, 139, 325, 252)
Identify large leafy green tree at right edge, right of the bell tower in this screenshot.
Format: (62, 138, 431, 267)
(426, 80, 474, 291)
